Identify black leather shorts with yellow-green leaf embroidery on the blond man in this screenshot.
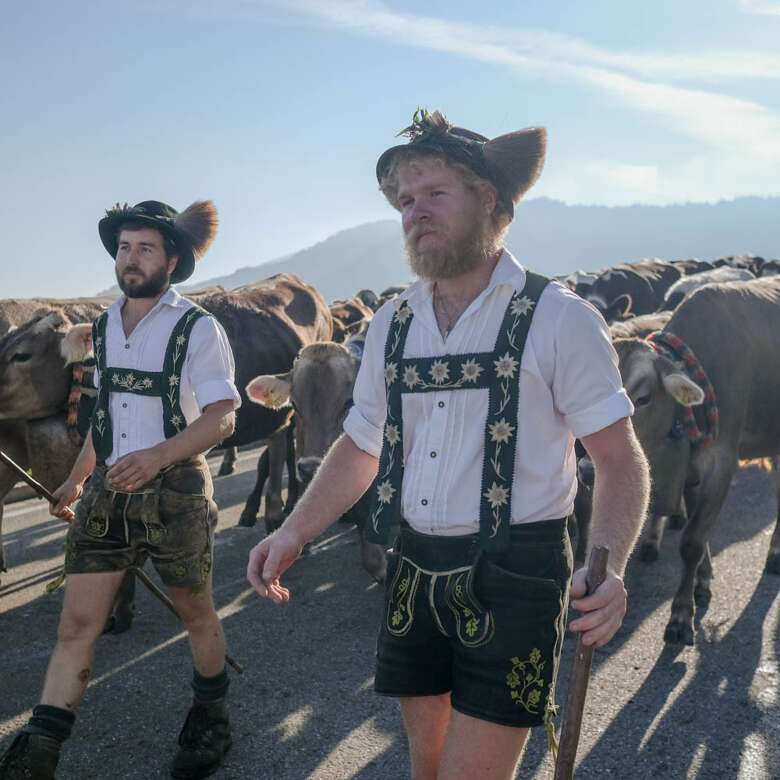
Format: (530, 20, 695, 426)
(374, 519, 572, 727)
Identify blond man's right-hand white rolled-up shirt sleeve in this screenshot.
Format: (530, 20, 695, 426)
(553, 297, 634, 438)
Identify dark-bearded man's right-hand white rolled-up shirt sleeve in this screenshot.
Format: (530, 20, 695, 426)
(187, 317, 241, 412)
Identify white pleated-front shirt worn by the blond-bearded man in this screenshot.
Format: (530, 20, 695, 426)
(344, 251, 633, 535)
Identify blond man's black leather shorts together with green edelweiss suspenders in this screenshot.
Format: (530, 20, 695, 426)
(365, 272, 571, 729)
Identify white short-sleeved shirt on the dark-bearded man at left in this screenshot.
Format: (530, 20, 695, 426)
(94, 287, 241, 465)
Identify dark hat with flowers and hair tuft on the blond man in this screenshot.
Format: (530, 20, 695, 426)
(376, 108, 547, 217)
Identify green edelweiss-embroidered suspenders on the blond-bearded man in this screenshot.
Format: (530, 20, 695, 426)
(365, 272, 549, 551)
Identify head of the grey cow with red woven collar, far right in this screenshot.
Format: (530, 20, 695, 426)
(614, 339, 704, 515)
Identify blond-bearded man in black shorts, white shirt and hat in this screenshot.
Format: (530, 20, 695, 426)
(248, 111, 649, 780)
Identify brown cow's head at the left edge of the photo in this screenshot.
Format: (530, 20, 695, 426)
(0, 310, 91, 420)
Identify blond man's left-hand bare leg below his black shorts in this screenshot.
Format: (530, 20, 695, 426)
(399, 693, 452, 780)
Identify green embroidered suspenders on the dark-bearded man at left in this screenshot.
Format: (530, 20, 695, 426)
(92, 306, 210, 463)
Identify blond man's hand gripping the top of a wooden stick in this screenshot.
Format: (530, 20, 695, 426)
(569, 568, 628, 647)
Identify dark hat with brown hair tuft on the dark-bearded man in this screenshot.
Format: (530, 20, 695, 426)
(98, 200, 217, 283)
